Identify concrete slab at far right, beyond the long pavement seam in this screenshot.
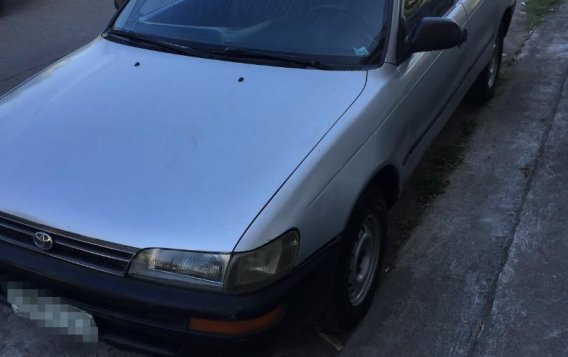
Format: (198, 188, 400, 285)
(476, 20, 568, 357)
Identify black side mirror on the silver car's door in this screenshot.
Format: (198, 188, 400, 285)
(409, 17, 467, 53)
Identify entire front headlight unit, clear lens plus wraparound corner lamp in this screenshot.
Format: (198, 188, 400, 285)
(128, 231, 300, 294)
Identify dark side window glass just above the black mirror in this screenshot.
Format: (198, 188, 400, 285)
(402, 0, 456, 35)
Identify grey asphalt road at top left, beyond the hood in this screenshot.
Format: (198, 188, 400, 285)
(0, 0, 114, 93)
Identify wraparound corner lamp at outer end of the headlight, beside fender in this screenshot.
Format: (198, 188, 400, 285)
(225, 231, 300, 293)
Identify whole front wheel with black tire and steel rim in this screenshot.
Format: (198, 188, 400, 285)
(333, 188, 387, 327)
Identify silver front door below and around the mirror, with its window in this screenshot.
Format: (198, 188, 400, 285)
(397, 0, 468, 172)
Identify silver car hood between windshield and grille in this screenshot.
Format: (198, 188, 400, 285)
(0, 39, 366, 252)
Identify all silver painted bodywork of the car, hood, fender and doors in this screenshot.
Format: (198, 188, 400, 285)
(0, 0, 510, 268)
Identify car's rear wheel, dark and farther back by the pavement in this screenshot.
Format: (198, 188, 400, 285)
(467, 28, 505, 105)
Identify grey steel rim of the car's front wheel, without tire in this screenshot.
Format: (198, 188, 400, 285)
(348, 214, 382, 307)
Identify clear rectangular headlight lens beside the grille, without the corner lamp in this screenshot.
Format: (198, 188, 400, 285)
(128, 249, 231, 290)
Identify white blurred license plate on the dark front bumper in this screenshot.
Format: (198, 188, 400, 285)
(6, 282, 98, 343)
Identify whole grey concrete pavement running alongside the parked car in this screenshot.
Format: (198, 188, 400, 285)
(342, 5, 568, 356)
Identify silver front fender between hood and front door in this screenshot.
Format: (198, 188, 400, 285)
(236, 64, 410, 262)
